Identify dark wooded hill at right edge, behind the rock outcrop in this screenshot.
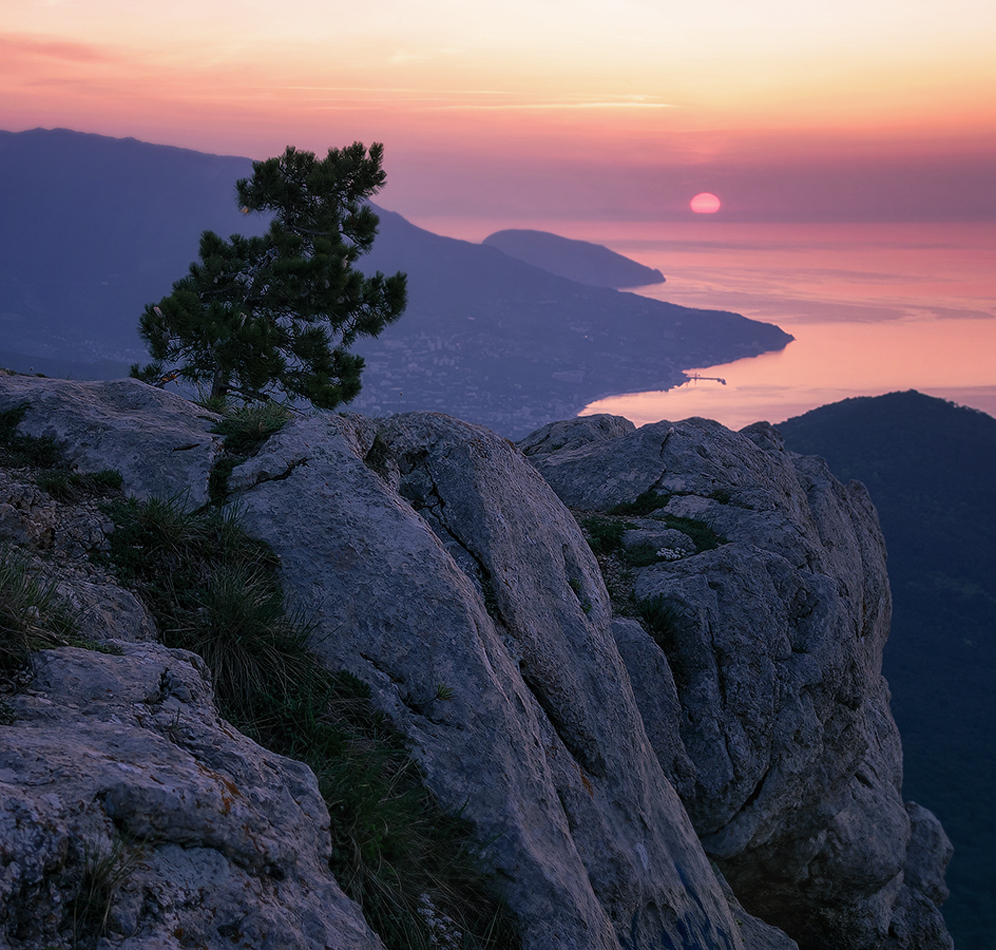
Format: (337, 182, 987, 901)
(778, 391, 996, 950)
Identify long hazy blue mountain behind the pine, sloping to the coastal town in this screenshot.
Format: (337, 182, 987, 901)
(0, 129, 792, 435)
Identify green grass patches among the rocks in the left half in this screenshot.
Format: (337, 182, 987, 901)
(0, 402, 519, 950)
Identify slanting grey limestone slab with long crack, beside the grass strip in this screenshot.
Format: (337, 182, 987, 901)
(229, 413, 742, 950)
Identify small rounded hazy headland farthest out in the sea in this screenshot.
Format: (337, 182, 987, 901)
(481, 228, 664, 287)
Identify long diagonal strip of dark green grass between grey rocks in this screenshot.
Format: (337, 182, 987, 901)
(107, 499, 519, 950)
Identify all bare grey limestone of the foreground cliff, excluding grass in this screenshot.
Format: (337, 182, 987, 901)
(0, 376, 950, 950)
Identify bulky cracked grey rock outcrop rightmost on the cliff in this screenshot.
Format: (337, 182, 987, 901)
(520, 419, 950, 950)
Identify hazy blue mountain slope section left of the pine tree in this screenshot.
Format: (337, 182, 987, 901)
(0, 129, 261, 368)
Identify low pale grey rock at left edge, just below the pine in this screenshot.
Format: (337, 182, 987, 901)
(0, 374, 221, 508)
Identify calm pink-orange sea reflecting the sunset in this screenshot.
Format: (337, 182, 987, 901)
(418, 218, 996, 428)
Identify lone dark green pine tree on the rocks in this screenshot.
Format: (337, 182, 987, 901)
(132, 142, 406, 409)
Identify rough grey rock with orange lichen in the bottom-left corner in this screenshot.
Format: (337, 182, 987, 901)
(0, 642, 382, 950)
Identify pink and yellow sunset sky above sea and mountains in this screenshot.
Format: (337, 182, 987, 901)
(0, 0, 996, 221)
